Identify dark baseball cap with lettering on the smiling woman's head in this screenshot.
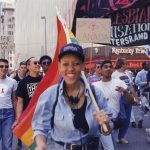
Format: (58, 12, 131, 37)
(58, 43, 84, 62)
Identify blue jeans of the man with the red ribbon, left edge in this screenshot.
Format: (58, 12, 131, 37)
(0, 108, 14, 150)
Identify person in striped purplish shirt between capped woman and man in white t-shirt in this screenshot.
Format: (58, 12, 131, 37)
(88, 62, 102, 84)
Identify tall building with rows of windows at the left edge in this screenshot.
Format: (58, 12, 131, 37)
(0, 2, 15, 69)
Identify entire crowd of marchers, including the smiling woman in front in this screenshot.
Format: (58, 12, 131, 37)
(0, 44, 150, 150)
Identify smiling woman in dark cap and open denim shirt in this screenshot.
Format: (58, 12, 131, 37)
(32, 44, 111, 150)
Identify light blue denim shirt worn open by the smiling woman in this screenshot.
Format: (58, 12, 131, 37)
(32, 81, 112, 144)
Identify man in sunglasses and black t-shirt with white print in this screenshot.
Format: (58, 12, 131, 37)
(13, 57, 42, 137)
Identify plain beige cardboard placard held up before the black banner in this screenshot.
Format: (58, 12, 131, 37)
(76, 18, 111, 43)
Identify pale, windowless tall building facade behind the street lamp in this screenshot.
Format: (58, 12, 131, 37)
(15, 0, 76, 63)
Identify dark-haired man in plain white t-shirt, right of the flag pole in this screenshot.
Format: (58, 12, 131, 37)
(94, 60, 133, 150)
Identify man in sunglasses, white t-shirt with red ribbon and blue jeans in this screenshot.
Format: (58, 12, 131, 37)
(0, 59, 17, 150)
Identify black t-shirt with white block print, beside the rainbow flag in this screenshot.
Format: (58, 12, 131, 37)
(16, 75, 42, 110)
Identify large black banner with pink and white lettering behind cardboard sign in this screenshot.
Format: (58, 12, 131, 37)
(72, 0, 150, 46)
